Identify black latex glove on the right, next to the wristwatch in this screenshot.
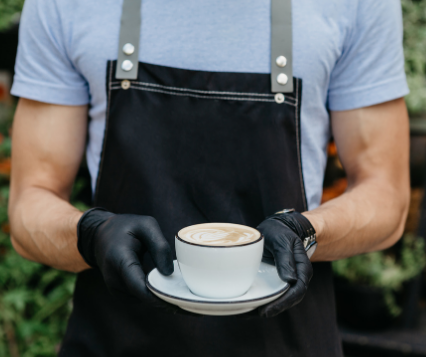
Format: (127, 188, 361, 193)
(257, 212, 315, 317)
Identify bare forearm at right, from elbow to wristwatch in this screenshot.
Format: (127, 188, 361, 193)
(303, 179, 409, 261)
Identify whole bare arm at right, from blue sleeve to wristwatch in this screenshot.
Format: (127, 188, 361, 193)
(304, 99, 409, 261)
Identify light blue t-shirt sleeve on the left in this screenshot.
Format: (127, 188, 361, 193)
(11, 0, 89, 105)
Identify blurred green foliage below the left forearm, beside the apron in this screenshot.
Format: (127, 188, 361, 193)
(0, 181, 87, 357)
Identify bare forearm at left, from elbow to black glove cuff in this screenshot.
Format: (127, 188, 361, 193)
(9, 187, 89, 272)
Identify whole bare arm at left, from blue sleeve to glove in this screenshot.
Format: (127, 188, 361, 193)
(9, 99, 88, 272)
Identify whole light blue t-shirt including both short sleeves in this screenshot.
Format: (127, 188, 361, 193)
(12, 0, 408, 209)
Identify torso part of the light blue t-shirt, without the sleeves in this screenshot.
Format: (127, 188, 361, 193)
(58, 0, 355, 208)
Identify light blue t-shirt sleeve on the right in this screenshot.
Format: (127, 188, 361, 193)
(328, 0, 409, 110)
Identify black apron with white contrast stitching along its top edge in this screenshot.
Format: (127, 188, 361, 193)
(59, 0, 342, 357)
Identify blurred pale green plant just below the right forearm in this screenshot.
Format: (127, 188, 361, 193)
(333, 234, 426, 316)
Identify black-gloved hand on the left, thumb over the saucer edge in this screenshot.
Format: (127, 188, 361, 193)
(77, 208, 180, 313)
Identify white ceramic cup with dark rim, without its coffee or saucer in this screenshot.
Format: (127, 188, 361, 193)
(175, 223, 264, 299)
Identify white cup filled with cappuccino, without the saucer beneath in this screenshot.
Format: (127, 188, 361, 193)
(175, 223, 264, 299)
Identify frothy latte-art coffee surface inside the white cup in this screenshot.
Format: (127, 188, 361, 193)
(178, 223, 260, 246)
